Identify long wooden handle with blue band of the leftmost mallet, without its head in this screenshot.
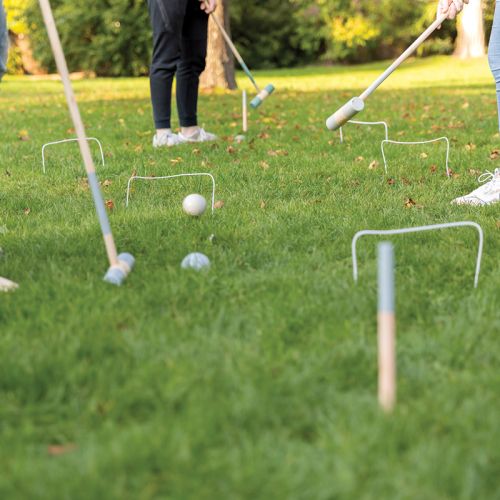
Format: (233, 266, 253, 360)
(39, 0, 118, 266)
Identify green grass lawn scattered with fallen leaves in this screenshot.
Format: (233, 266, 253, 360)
(0, 58, 500, 500)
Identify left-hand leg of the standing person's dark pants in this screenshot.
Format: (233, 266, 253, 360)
(148, 0, 187, 130)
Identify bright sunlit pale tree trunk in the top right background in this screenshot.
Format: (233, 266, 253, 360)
(455, 0, 486, 59)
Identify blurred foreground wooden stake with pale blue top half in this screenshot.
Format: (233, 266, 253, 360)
(378, 242, 396, 413)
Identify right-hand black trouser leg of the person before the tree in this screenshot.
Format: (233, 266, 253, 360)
(176, 0, 208, 127)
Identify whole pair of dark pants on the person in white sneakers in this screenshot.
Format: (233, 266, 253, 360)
(148, 0, 208, 129)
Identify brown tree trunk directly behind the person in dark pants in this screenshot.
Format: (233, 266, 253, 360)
(200, 0, 237, 89)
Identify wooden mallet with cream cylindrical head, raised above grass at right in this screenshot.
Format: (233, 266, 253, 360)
(326, 14, 447, 130)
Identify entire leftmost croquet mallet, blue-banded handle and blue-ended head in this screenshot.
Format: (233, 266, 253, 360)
(39, 0, 135, 285)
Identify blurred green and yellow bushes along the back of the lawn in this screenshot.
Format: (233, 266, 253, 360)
(4, 0, 494, 76)
